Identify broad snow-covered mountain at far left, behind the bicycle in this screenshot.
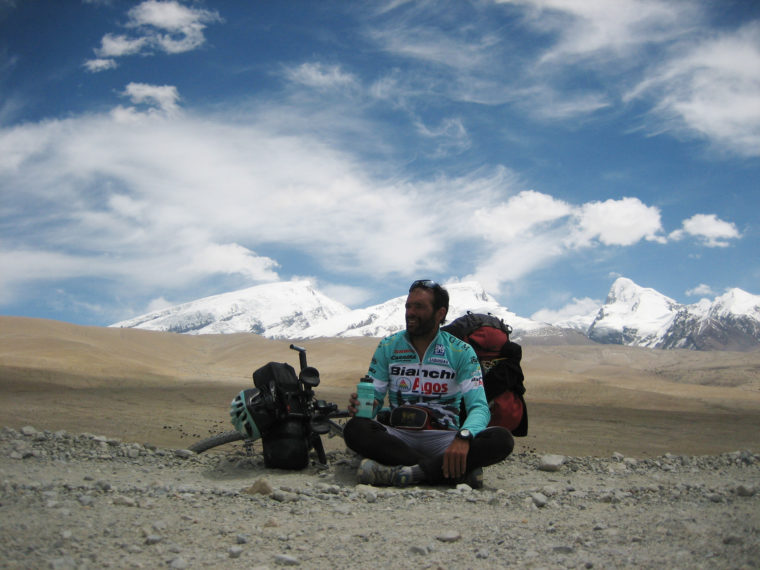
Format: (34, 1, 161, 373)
(111, 281, 350, 338)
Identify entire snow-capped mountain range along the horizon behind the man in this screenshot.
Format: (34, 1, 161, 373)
(111, 278, 760, 350)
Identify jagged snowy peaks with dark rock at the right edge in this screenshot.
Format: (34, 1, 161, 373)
(587, 278, 760, 350)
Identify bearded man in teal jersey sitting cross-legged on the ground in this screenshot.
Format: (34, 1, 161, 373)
(343, 280, 514, 488)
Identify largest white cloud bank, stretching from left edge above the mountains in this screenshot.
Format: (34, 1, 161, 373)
(0, 76, 724, 310)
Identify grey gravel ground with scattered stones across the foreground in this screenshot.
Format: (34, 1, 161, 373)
(0, 426, 760, 569)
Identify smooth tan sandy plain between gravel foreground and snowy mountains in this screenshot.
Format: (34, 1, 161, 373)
(0, 317, 760, 458)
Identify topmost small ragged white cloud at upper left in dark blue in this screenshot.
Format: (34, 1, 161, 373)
(84, 0, 221, 72)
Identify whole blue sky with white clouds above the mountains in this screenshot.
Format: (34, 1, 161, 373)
(0, 0, 760, 325)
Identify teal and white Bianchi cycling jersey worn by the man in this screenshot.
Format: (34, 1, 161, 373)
(368, 330, 491, 435)
